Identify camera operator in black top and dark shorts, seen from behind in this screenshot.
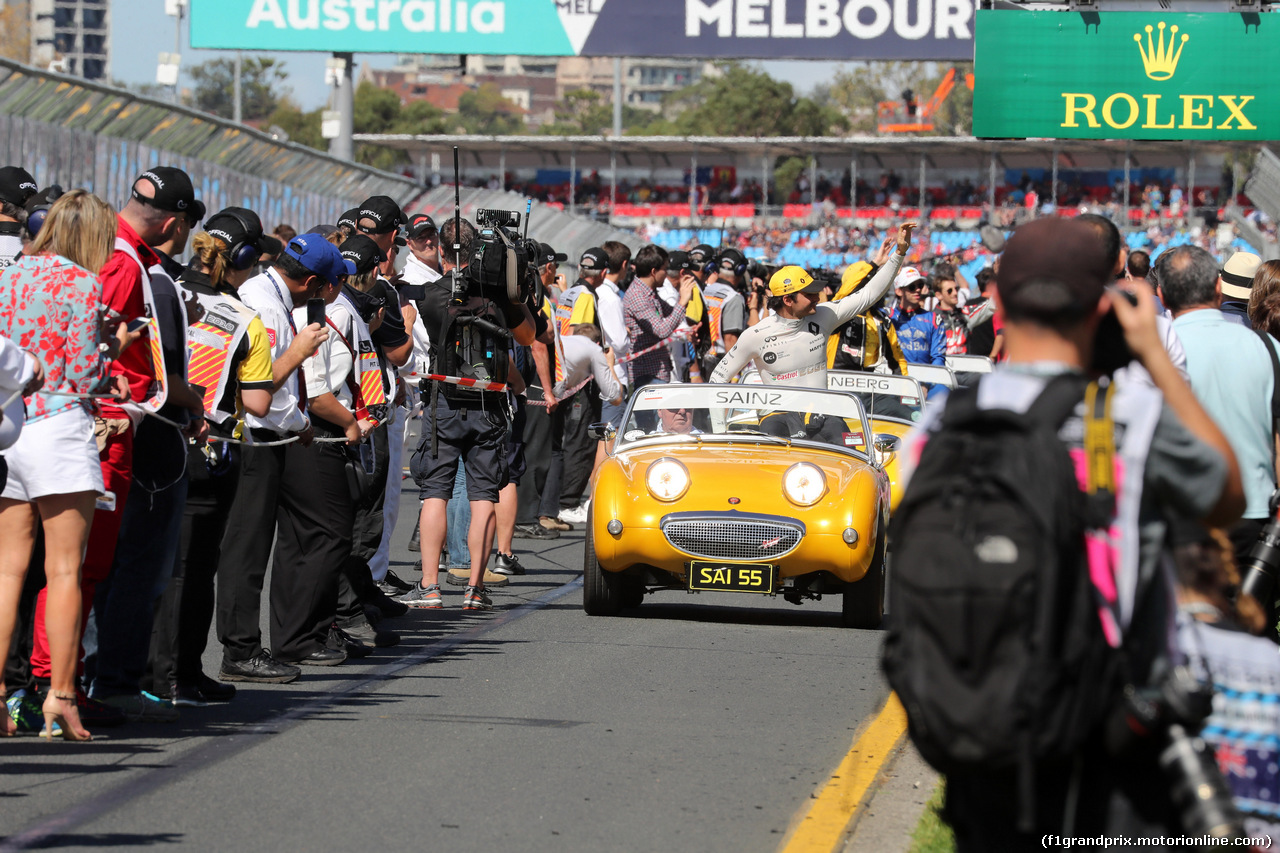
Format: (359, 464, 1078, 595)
(399, 213, 535, 613)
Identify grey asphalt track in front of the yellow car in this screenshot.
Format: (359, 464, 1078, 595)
(0, 481, 888, 853)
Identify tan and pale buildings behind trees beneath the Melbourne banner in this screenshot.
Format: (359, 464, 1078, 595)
(362, 55, 714, 127)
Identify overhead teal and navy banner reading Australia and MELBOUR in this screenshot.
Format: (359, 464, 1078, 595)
(191, 0, 974, 60)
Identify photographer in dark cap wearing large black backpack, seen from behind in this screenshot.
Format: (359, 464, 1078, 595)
(883, 219, 1245, 852)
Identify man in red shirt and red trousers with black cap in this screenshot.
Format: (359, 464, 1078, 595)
(31, 167, 196, 725)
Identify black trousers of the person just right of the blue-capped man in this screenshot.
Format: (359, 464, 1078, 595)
(267, 432, 353, 661)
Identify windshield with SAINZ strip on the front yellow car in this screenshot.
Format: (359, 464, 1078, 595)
(620, 384, 867, 453)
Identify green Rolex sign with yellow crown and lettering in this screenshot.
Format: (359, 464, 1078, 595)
(973, 10, 1280, 140)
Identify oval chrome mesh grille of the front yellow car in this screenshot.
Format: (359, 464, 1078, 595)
(660, 512, 804, 562)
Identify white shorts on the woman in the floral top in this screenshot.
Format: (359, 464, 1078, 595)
(0, 406, 102, 501)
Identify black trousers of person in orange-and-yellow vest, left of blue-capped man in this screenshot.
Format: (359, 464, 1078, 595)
(142, 443, 241, 695)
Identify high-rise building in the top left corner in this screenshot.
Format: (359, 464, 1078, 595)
(28, 0, 111, 81)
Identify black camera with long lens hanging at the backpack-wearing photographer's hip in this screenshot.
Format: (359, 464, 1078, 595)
(1107, 666, 1244, 838)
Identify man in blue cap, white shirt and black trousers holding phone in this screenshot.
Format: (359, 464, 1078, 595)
(218, 234, 353, 684)
